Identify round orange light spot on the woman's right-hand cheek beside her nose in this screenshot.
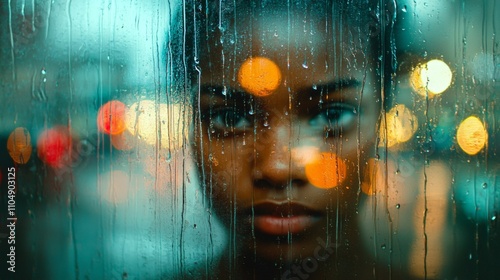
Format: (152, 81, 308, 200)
(305, 152, 347, 189)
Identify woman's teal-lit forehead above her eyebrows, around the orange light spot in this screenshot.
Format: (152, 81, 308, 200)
(200, 5, 371, 85)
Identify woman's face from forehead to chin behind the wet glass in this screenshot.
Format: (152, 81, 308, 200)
(198, 8, 380, 261)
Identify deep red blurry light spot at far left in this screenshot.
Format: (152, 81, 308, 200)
(37, 127, 72, 168)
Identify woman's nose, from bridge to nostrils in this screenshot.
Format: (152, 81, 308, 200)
(253, 123, 308, 189)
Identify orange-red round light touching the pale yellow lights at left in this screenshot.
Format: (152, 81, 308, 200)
(97, 100, 127, 135)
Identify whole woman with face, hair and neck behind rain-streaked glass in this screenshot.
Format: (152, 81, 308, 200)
(186, 1, 383, 279)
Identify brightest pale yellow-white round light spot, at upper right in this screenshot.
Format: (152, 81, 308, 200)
(410, 59, 453, 98)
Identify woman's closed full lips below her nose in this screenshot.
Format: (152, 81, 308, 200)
(248, 201, 320, 235)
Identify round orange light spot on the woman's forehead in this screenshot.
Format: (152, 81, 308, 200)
(238, 57, 281, 96)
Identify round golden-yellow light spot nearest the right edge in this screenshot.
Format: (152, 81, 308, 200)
(457, 116, 488, 155)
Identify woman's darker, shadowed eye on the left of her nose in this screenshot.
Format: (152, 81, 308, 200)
(211, 107, 252, 133)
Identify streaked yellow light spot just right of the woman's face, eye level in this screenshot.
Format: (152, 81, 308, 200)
(379, 104, 418, 148)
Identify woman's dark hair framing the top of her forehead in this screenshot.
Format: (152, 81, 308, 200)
(171, 0, 396, 105)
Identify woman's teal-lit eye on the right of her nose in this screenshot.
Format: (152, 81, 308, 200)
(309, 102, 357, 135)
